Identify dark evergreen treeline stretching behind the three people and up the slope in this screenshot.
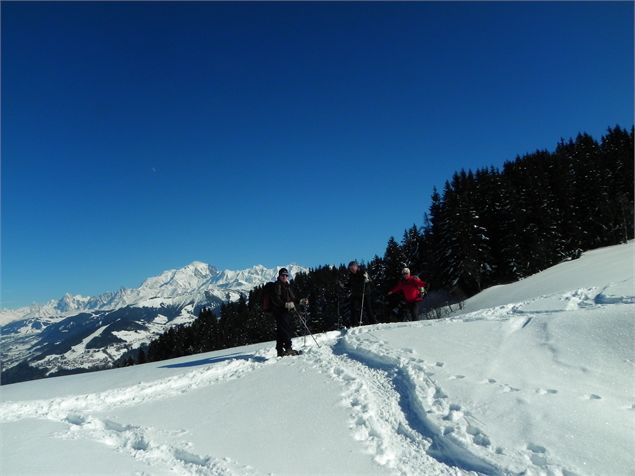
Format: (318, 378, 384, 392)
(122, 127, 635, 364)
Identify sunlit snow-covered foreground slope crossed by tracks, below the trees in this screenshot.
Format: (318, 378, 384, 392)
(0, 243, 635, 476)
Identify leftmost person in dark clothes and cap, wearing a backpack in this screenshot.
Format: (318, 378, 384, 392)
(271, 268, 299, 357)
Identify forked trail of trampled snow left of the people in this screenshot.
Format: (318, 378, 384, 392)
(0, 351, 275, 476)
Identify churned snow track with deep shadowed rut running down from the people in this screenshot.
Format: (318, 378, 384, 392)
(307, 330, 500, 474)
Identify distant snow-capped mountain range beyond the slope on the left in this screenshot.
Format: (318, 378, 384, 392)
(0, 261, 306, 384)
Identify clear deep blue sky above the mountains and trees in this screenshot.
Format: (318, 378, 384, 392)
(2, 2, 633, 307)
